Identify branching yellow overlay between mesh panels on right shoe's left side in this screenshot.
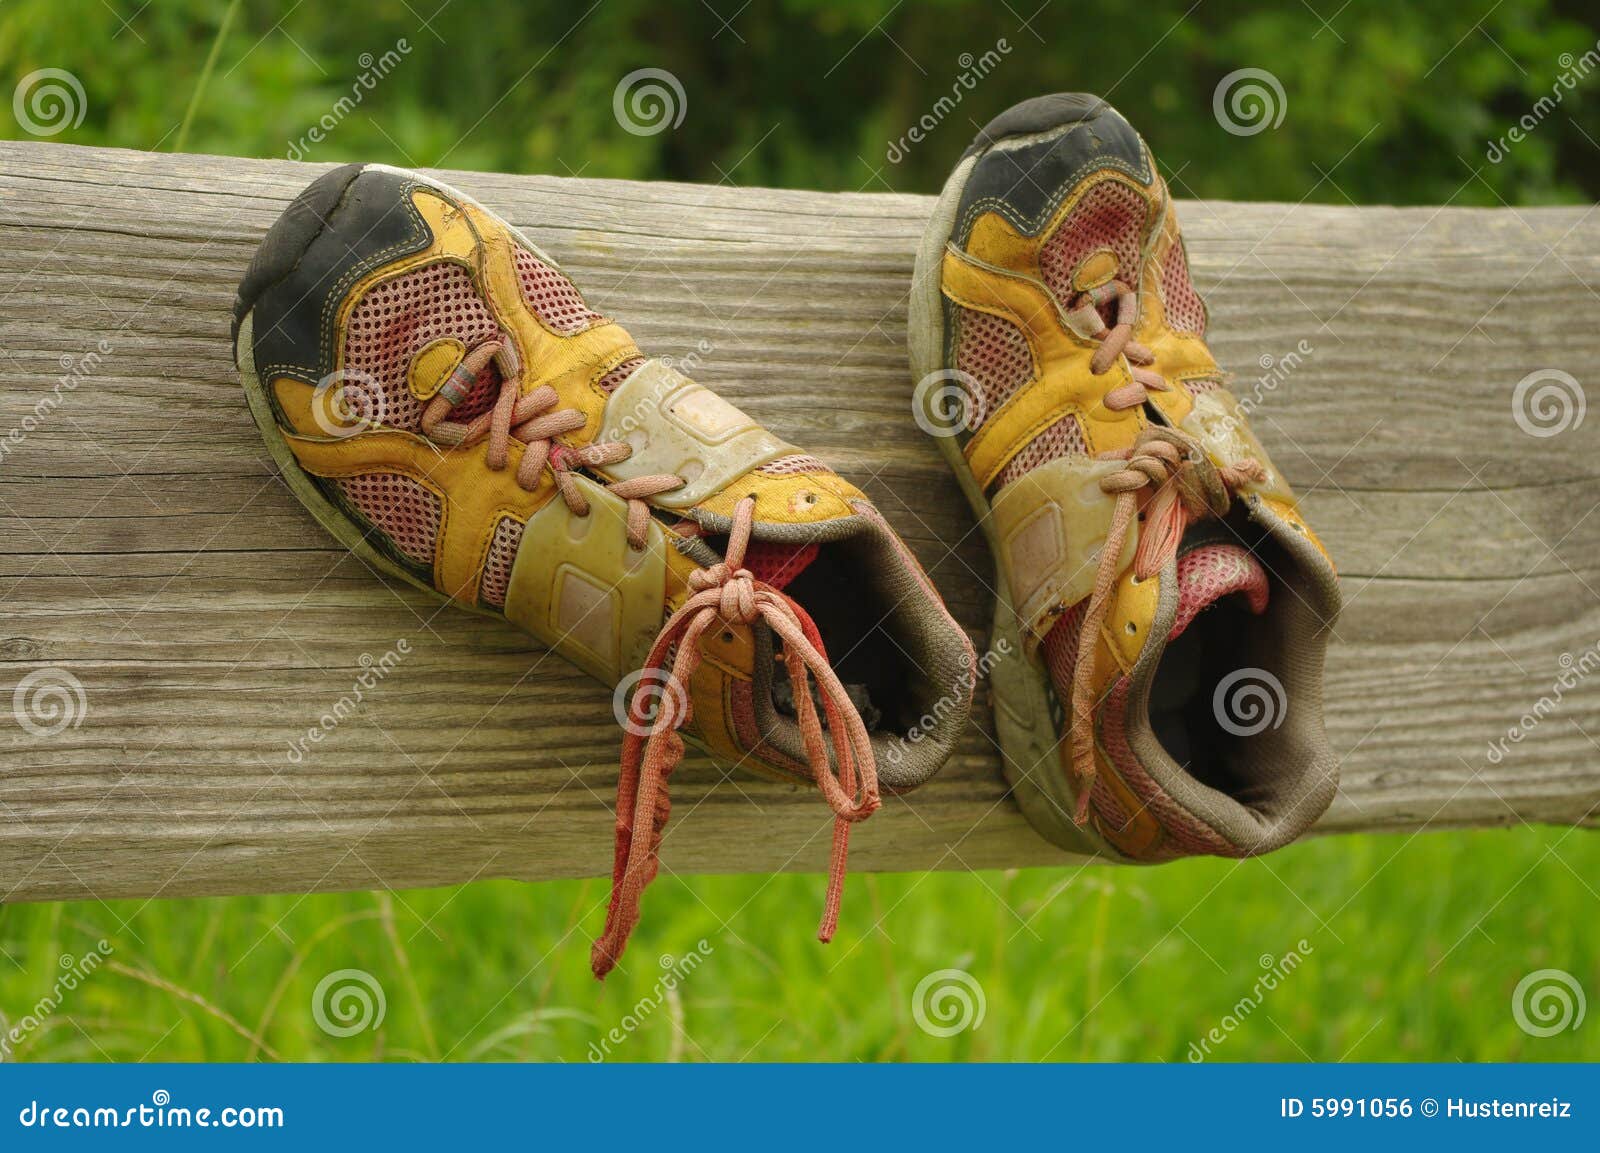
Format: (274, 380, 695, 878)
(941, 249, 1144, 488)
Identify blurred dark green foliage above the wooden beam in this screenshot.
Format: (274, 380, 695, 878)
(0, 0, 1600, 205)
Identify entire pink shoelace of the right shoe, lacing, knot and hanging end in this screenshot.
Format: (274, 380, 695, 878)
(1070, 292, 1266, 825)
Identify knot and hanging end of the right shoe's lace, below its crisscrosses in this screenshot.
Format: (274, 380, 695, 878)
(1072, 427, 1266, 825)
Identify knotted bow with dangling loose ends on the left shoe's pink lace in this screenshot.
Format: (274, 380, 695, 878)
(590, 497, 882, 979)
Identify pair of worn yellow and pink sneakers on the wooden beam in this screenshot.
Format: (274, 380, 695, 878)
(234, 94, 1339, 975)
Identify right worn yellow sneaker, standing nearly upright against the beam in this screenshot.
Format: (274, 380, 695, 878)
(910, 94, 1339, 860)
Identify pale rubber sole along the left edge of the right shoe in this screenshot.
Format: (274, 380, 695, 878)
(907, 93, 1120, 859)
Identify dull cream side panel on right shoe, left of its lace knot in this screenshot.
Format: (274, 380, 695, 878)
(990, 454, 1154, 644)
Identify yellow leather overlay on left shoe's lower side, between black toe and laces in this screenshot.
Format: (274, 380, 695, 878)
(285, 422, 560, 604)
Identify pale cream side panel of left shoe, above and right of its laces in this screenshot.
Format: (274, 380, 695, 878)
(597, 360, 797, 510)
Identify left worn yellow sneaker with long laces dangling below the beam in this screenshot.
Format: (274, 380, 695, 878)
(234, 165, 971, 975)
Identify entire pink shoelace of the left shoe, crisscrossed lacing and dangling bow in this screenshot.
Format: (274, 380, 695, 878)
(422, 341, 882, 979)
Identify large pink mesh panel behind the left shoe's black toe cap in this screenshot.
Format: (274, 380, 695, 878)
(344, 264, 499, 430)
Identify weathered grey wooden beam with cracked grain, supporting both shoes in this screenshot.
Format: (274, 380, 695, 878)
(0, 144, 1600, 900)
